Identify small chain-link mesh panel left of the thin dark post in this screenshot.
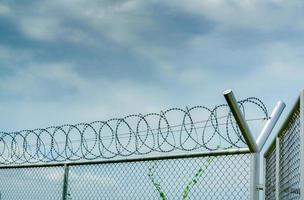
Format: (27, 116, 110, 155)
(0, 167, 64, 200)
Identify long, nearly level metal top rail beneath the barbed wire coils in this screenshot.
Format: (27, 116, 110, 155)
(0, 148, 251, 169)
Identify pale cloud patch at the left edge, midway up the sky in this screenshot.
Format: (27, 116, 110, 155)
(0, 63, 81, 101)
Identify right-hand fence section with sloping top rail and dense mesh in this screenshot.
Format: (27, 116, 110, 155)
(265, 93, 304, 200)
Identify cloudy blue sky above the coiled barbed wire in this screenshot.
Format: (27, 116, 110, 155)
(0, 0, 304, 131)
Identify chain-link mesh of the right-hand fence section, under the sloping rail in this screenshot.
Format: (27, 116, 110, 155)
(265, 105, 301, 200)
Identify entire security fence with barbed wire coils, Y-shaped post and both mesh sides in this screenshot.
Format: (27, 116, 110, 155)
(0, 92, 301, 200)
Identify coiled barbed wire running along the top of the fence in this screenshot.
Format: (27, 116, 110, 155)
(0, 97, 269, 165)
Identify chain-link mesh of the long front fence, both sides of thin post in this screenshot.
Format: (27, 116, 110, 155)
(0, 153, 251, 200)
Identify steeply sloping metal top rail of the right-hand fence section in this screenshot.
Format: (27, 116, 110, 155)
(264, 97, 300, 157)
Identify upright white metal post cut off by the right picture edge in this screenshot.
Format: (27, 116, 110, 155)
(300, 90, 304, 200)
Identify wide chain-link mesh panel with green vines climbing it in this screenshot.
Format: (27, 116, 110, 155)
(68, 154, 251, 200)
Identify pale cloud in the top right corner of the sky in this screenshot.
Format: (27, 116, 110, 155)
(170, 0, 303, 31)
